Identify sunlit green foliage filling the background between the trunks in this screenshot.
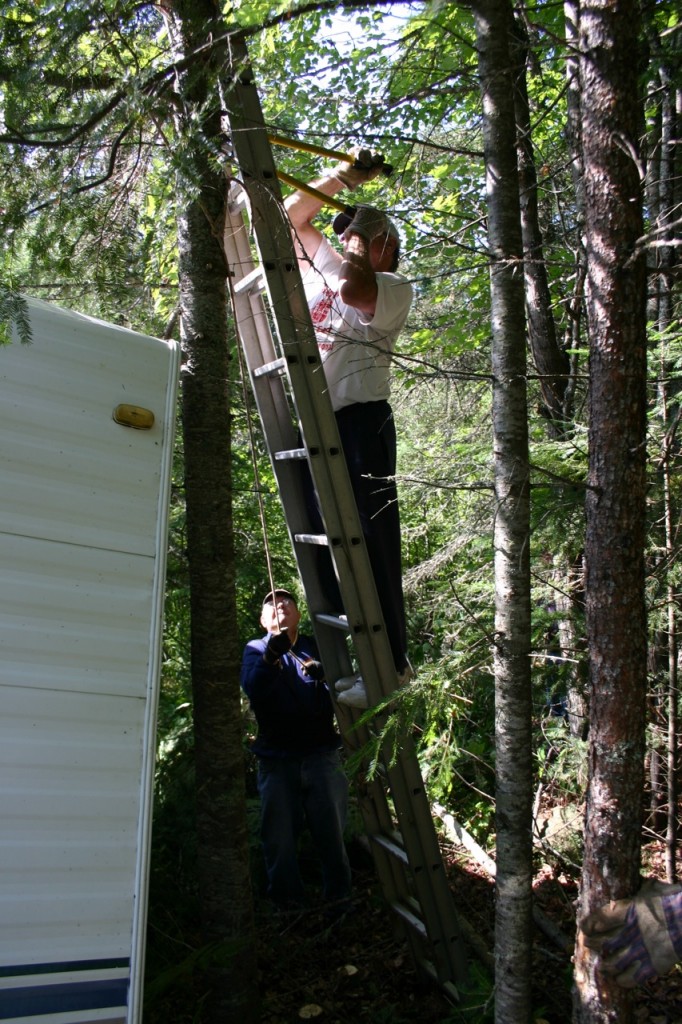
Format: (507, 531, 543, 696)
(0, 0, 682, 1015)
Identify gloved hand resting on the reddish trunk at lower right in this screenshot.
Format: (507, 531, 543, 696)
(581, 880, 682, 988)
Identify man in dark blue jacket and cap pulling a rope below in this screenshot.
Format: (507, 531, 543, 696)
(241, 590, 350, 908)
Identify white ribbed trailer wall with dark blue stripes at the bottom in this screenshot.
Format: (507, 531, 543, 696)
(0, 300, 179, 1024)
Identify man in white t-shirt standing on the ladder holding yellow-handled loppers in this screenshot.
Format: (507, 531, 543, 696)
(285, 151, 413, 707)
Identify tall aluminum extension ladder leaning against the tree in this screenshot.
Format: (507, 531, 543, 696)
(224, 37, 467, 999)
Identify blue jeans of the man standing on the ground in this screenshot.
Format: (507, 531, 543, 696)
(258, 751, 350, 904)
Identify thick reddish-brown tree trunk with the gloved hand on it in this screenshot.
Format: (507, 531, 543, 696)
(573, 0, 647, 1024)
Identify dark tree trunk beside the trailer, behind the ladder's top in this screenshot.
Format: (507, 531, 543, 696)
(163, 0, 259, 1024)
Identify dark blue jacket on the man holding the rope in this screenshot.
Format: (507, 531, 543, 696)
(241, 634, 341, 758)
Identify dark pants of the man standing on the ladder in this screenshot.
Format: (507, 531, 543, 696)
(305, 401, 408, 672)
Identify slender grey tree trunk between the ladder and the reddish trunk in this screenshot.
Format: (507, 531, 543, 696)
(466, 0, 532, 1024)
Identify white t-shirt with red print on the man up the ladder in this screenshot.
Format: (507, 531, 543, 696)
(303, 238, 413, 412)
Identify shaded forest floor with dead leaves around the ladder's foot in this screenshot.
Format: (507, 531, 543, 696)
(250, 831, 682, 1024)
